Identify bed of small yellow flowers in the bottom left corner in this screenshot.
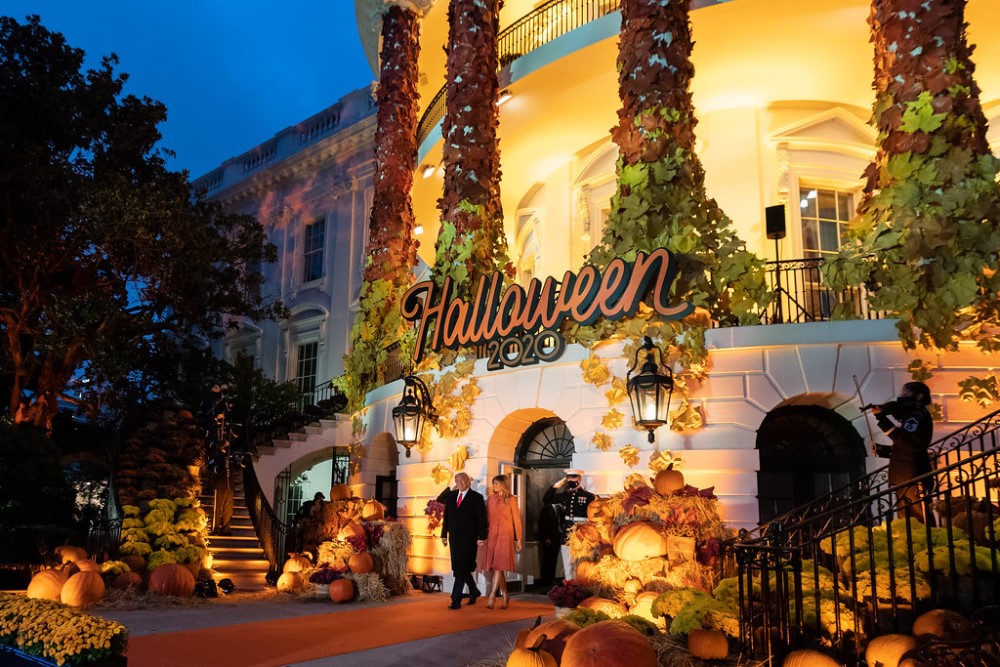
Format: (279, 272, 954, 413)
(0, 593, 128, 665)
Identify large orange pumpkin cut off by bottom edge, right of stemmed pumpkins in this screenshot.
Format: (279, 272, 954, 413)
(559, 621, 657, 667)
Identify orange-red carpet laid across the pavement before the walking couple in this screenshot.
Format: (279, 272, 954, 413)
(128, 595, 553, 667)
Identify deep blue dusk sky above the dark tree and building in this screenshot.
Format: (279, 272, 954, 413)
(0, 0, 374, 178)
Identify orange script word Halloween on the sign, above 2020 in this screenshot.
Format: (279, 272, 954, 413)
(400, 248, 694, 361)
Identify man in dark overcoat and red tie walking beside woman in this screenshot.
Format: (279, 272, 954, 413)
(441, 472, 486, 609)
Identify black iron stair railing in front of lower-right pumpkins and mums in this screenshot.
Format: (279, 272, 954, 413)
(734, 412, 1000, 664)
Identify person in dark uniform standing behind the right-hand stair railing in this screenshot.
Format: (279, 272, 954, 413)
(865, 382, 934, 525)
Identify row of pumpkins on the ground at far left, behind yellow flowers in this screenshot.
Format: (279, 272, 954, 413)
(26, 546, 195, 607)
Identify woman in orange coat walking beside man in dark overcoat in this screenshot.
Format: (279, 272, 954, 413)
(479, 475, 524, 609)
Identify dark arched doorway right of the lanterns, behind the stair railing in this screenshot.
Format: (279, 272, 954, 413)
(757, 405, 865, 523)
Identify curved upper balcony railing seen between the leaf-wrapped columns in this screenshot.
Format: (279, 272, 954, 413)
(417, 0, 620, 146)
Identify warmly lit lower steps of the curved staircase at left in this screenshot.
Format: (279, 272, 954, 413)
(201, 466, 270, 591)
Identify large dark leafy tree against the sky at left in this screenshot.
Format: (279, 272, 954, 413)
(0, 16, 282, 429)
